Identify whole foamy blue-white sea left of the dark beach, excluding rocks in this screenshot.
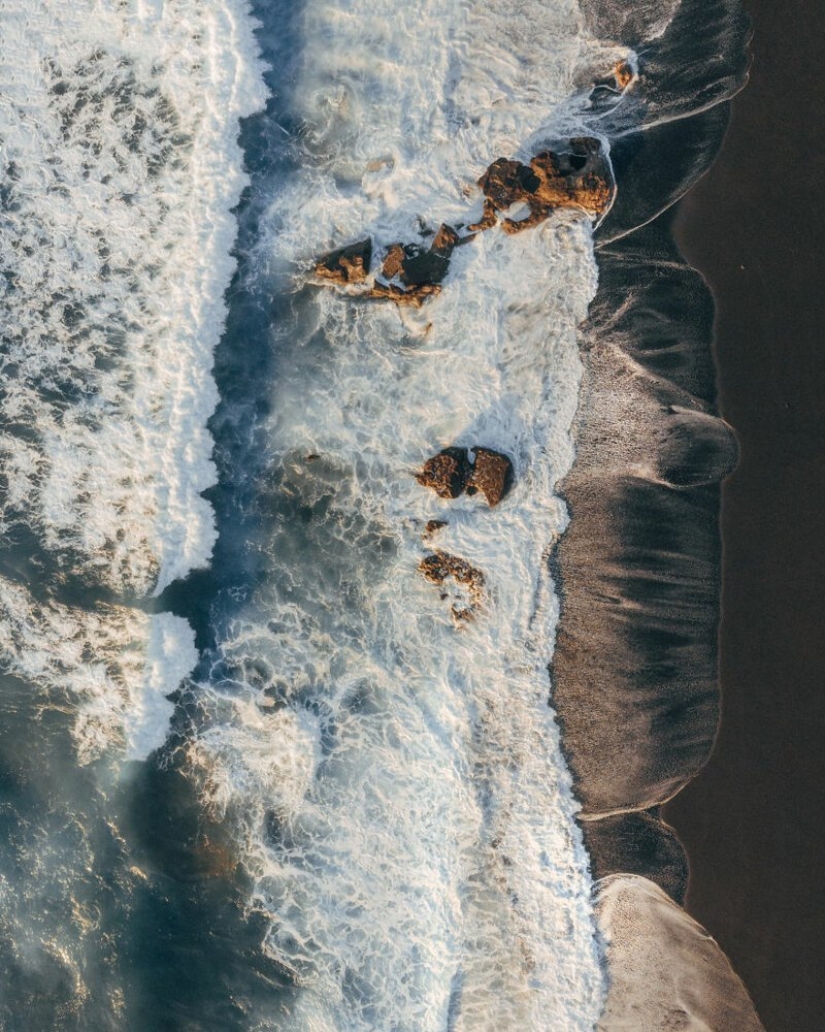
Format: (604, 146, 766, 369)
(0, 0, 759, 1032)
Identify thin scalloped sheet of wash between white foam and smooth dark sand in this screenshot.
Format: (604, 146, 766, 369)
(553, 4, 761, 1030)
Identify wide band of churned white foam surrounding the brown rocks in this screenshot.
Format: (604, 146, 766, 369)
(190, 0, 640, 1032)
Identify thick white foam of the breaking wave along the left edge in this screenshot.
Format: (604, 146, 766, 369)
(0, 0, 263, 755)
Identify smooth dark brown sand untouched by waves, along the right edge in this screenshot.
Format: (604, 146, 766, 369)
(664, 0, 825, 1032)
